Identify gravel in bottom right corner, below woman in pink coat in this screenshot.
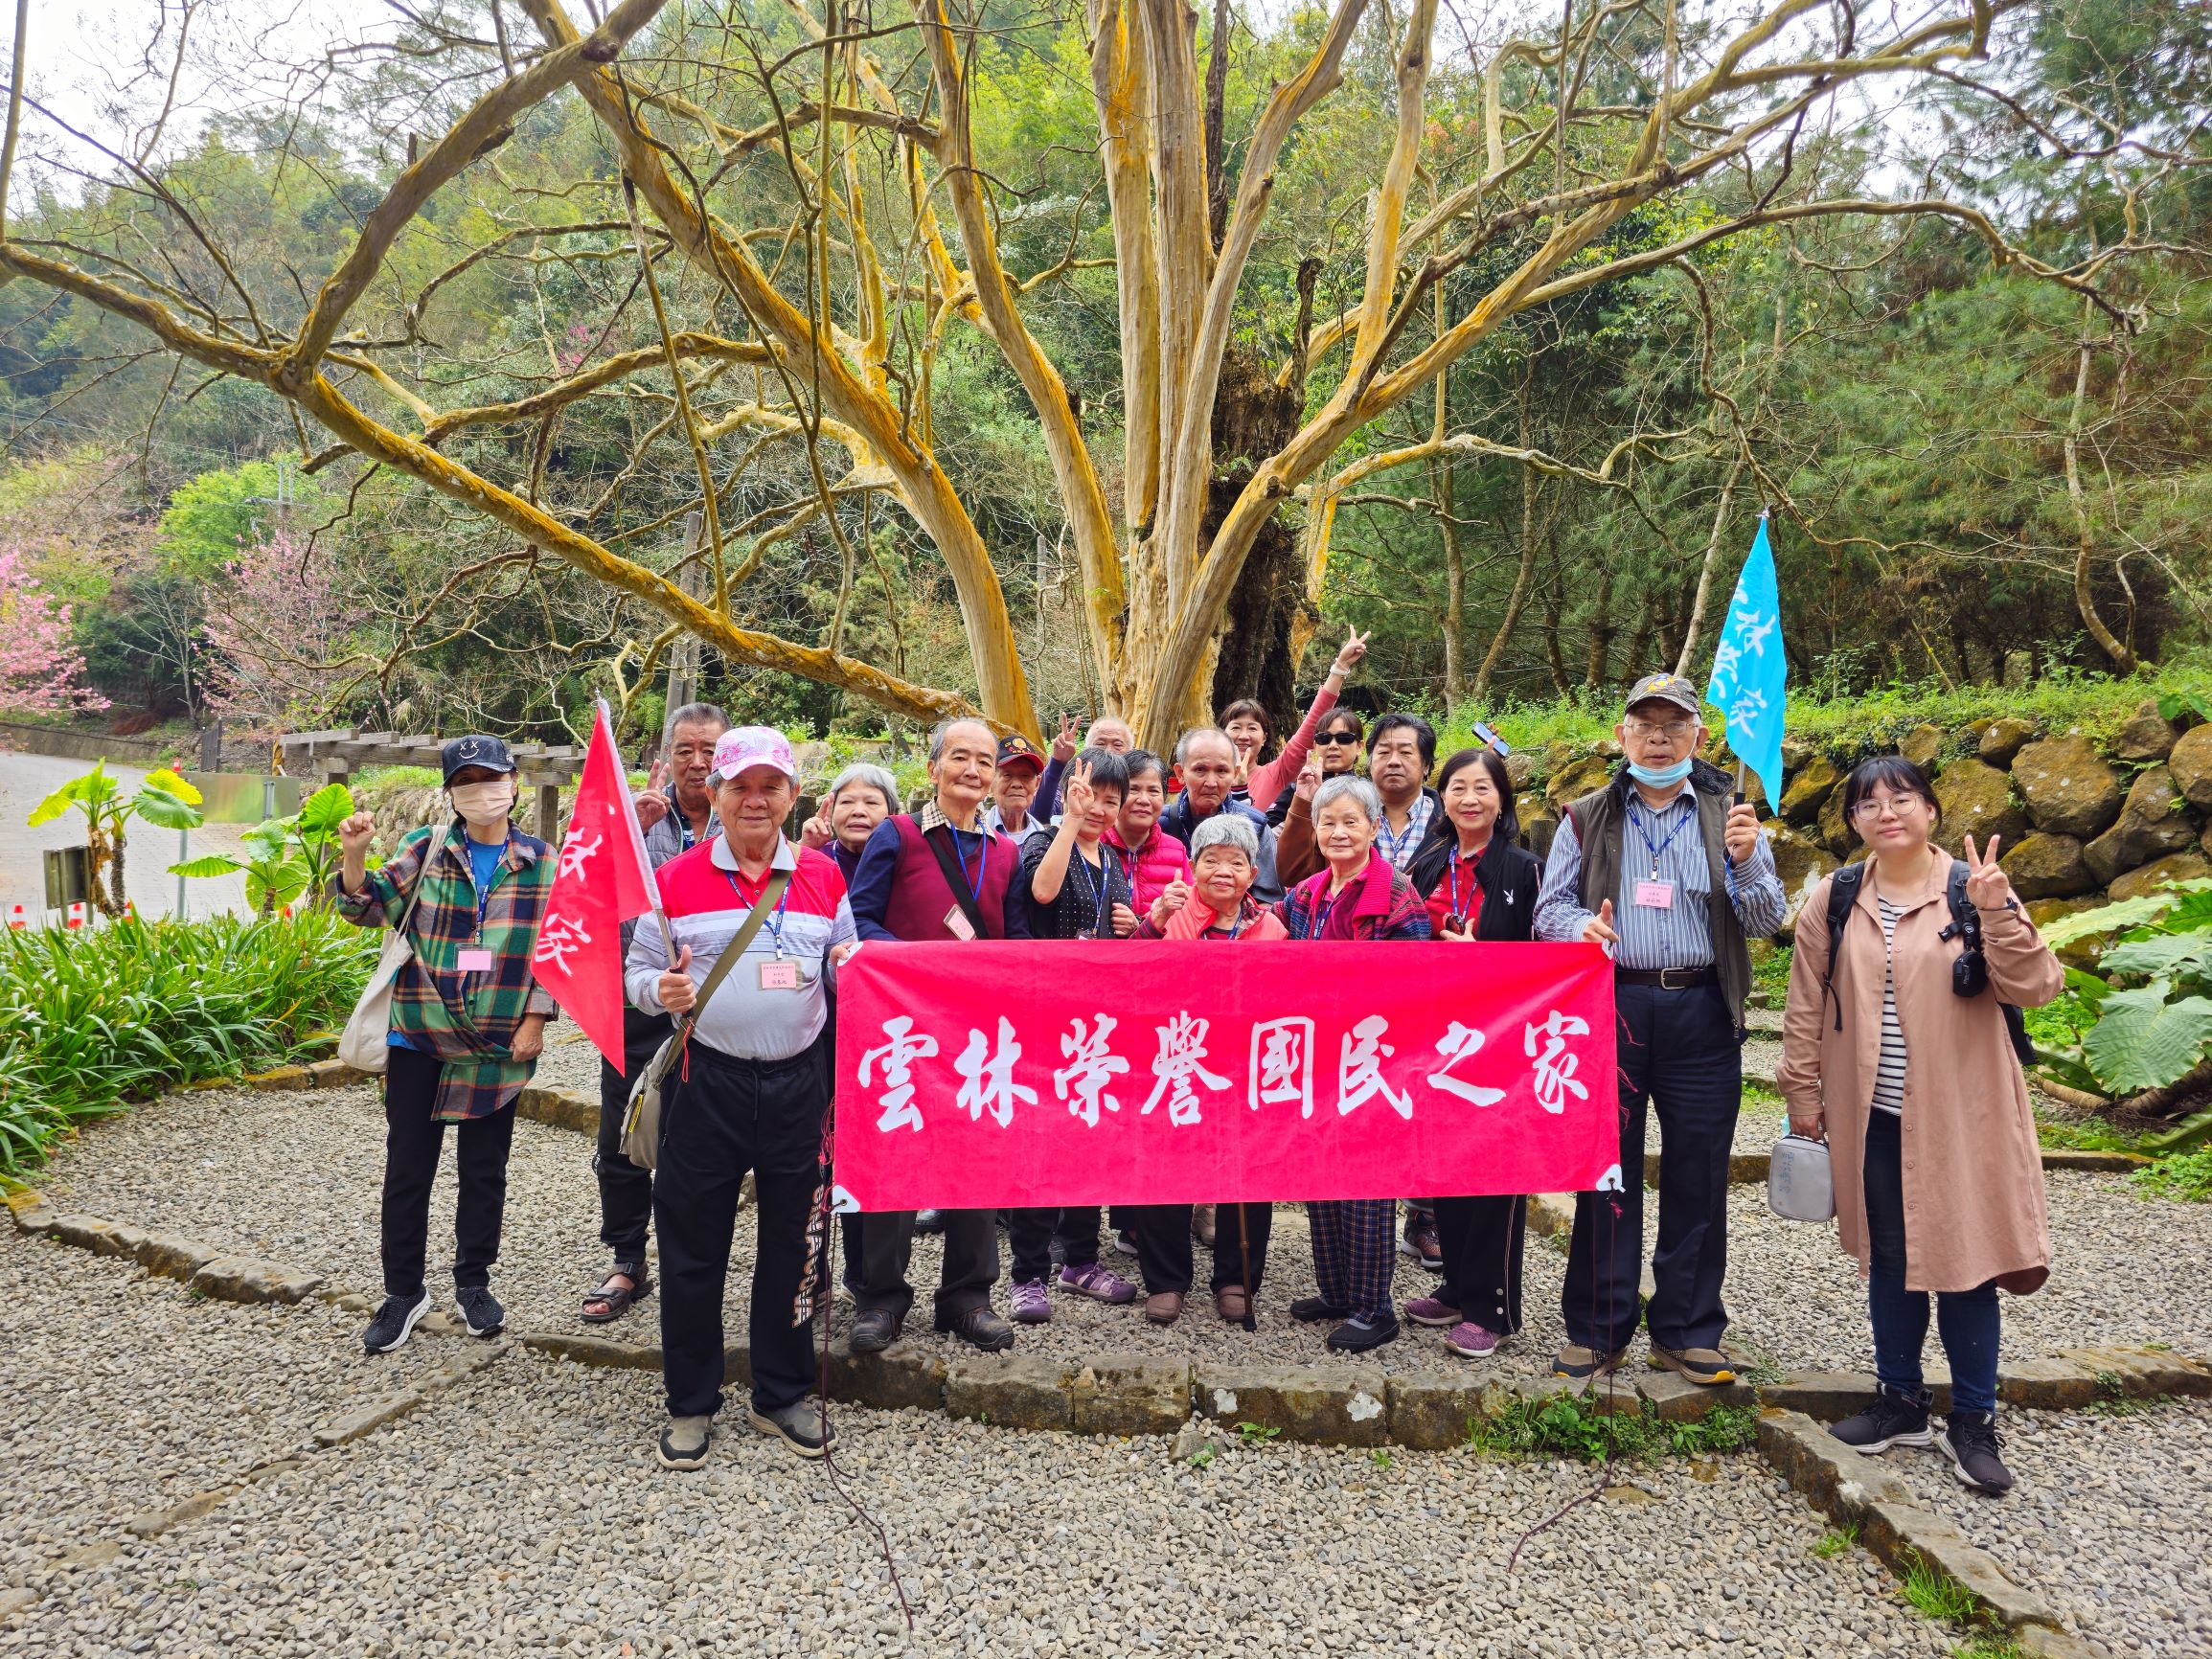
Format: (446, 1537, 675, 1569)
(1884, 1400, 2212, 1659)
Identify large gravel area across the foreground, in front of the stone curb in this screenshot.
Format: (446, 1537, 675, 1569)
(0, 1352, 1951, 1659)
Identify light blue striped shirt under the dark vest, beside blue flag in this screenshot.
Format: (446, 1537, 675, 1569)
(1535, 784, 1790, 971)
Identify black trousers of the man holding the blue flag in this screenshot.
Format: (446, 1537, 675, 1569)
(1560, 985, 1743, 1353)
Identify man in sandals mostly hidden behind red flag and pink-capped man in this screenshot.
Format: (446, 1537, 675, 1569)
(580, 703, 730, 1325)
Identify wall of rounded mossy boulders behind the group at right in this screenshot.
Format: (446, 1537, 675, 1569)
(1509, 703, 2212, 942)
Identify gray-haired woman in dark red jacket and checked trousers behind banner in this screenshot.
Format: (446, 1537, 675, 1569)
(1274, 777, 1431, 1353)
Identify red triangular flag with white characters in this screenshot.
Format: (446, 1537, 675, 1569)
(531, 701, 661, 1071)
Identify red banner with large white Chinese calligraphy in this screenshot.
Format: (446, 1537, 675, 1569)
(836, 940, 1619, 1210)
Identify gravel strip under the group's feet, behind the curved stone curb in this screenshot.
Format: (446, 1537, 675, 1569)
(42, 1088, 2212, 1375)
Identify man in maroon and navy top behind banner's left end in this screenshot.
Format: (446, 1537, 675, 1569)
(852, 719, 1029, 1353)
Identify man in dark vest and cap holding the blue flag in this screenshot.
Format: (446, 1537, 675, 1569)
(1535, 674, 1785, 1385)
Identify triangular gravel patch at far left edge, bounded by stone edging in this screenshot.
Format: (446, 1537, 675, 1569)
(0, 1228, 451, 1588)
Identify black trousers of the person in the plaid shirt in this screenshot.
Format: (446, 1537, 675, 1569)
(380, 1049, 515, 1299)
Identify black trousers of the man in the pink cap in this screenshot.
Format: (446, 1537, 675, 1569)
(652, 1039, 830, 1418)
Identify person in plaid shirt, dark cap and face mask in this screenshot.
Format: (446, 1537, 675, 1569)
(331, 737, 556, 1353)
